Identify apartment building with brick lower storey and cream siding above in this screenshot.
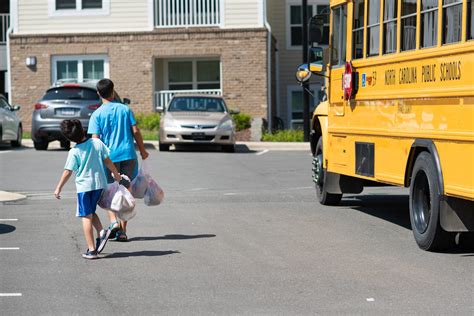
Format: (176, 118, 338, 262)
(9, 0, 328, 133)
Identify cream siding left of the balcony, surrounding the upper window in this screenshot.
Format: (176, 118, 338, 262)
(16, 0, 149, 34)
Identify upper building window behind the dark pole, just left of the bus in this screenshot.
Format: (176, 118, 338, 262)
(287, 1, 329, 49)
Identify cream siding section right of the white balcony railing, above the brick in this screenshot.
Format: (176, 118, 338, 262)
(224, 0, 263, 28)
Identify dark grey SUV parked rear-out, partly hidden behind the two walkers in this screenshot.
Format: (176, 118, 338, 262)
(31, 82, 130, 150)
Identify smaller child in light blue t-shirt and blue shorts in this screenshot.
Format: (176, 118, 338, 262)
(54, 120, 120, 259)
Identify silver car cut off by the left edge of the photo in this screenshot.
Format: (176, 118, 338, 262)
(0, 94, 23, 147)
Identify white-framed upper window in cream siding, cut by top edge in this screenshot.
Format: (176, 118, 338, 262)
(48, 0, 110, 16)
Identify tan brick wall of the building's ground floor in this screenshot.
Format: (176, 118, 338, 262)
(10, 28, 267, 130)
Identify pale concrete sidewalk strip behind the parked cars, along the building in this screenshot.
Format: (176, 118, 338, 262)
(19, 139, 310, 153)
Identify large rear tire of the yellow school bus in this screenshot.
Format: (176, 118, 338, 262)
(409, 151, 454, 251)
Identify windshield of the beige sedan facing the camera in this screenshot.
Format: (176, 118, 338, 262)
(168, 97, 227, 112)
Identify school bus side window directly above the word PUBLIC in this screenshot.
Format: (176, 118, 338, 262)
(420, 0, 438, 47)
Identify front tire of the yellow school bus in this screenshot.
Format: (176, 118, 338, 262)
(313, 137, 342, 205)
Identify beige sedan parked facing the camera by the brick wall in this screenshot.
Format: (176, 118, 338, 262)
(159, 94, 238, 152)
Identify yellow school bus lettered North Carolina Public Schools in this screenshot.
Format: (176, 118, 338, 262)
(296, 0, 474, 251)
